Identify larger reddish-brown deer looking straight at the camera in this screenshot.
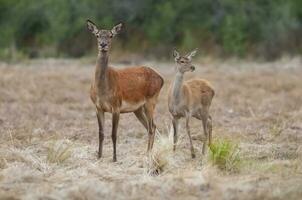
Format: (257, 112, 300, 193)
(87, 20, 164, 161)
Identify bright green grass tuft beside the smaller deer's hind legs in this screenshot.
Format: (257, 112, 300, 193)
(209, 139, 241, 172)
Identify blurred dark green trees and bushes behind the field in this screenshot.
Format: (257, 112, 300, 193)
(0, 0, 302, 59)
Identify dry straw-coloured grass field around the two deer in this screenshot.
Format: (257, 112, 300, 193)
(0, 58, 302, 200)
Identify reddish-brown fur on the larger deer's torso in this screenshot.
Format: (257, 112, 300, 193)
(90, 66, 164, 113)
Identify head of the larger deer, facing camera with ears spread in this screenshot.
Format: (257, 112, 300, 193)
(87, 20, 122, 52)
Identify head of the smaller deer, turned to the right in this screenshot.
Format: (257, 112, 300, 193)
(173, 49, 197, 73)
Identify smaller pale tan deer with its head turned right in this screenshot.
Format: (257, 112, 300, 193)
(168, 50, 215, 158)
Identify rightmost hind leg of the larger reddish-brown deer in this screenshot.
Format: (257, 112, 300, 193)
(144, 103, 155, 152)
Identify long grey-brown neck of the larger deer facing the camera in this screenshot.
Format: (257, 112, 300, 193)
(95, 52, 109, 92)
